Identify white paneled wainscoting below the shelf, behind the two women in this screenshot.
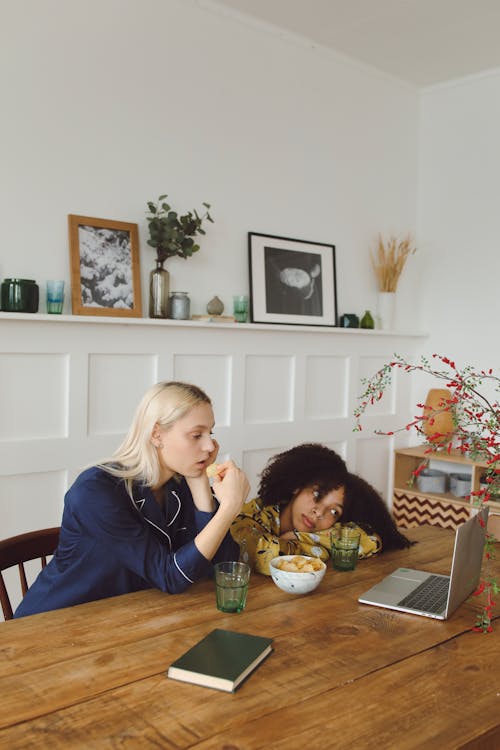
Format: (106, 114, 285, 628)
(0, 313, 423, 620)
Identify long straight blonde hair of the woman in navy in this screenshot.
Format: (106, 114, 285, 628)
(98, 381, 212, 498)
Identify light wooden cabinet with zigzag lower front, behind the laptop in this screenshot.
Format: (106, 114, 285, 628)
(392, 445, 500, 540)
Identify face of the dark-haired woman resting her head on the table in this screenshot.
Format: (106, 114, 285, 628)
(290, 487, 344, 533)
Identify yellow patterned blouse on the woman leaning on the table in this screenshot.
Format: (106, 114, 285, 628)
(231, 498, 382, 576)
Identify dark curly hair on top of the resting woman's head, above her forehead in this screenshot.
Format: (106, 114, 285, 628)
(259, 443, 347, 506)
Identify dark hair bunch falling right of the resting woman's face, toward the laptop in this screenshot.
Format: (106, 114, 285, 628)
(342, 474, 415, 551)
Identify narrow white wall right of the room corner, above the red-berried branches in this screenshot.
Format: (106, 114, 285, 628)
(418, 71, 500, 368)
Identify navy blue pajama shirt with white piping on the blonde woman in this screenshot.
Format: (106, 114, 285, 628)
(14, 466, 239, 617)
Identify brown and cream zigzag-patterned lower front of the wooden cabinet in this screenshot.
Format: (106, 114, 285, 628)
(392, 492, 472, 529)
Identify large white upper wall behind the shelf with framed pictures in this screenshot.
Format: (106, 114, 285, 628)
(0, 0, 419, 329)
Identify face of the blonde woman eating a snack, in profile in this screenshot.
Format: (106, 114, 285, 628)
(153, 403, 218, 478)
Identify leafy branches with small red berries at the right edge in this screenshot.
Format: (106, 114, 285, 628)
(354, 354, 500, 632)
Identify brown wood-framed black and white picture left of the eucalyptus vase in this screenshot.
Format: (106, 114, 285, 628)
(68, 214, 142, 318)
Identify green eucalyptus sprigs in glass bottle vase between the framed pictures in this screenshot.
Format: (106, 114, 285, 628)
(146, 194, 213, 318)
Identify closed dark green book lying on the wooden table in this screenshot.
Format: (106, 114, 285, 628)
(167, 629, 273, 693)
